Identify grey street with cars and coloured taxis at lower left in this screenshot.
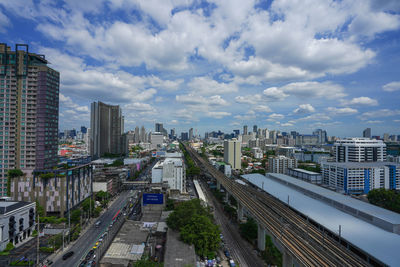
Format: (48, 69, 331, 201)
(53, 191, 130, 266)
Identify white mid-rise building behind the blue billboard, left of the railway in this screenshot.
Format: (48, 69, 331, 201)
(151, 158, 186, 192)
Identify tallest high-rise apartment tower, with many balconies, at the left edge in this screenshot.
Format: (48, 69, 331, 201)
(0, 43, 60, 196)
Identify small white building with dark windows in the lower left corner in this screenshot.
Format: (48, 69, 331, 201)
(0, 201, 36, 251)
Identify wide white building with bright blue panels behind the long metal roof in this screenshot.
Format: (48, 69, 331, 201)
(321, 162, 400, 194)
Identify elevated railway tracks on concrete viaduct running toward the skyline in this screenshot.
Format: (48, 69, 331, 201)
(185, 145, 369, 266)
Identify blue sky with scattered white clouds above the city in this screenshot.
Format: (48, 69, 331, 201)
(0, 0, 400, 137)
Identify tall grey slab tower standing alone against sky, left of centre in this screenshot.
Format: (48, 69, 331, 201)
(90, 101, 124, 158)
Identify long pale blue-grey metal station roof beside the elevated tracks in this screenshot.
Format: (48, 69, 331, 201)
(242, 173, 400, 266)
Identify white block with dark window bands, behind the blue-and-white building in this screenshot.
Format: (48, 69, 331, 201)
(333, 138, 386, 162)
